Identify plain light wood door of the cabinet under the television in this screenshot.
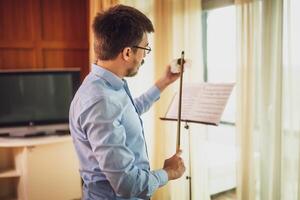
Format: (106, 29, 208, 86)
(26, 141, 81, 200)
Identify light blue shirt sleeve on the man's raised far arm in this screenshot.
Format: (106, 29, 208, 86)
(134, 85, 160, 115)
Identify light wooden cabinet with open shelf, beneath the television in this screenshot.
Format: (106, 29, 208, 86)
(0, 135, 81, 200)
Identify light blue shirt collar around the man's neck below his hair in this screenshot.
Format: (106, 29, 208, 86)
(91, 64, 124, 90)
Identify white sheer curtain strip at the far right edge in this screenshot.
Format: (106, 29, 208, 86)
(281, 0, 300, 200)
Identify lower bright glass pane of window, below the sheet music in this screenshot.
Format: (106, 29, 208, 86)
(207, 125, 236, 194)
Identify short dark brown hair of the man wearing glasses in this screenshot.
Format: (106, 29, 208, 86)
(93, 5, 154, 60)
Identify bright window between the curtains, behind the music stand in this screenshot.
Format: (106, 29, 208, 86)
(202, 6, 236, 194)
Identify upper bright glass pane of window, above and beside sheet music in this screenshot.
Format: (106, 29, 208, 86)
(207, 6, 236, 122)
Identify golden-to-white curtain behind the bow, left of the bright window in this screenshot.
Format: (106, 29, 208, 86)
(153, 0, 205, 200)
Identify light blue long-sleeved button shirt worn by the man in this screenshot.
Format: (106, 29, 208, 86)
(69, 64, 168, 200)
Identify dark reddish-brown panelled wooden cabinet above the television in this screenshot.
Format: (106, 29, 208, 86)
(0, 0, 90, 78)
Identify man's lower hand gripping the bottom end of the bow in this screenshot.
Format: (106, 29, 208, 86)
(163, 150, 185, 180)
